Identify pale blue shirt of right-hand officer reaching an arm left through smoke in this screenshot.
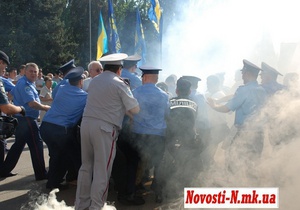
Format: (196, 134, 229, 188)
(226, 81, 266, 127)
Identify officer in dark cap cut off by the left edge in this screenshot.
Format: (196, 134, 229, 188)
(0, 51, 25, 177)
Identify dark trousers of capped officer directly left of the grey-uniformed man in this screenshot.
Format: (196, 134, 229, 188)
(40, 122, 80, 188)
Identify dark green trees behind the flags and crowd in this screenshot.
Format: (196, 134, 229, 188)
(0, 0, 175, 72)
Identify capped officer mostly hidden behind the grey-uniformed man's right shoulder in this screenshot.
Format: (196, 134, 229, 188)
(121, 55, 142, 90)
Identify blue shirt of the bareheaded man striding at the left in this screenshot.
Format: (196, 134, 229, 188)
(11, 76, 41, 119)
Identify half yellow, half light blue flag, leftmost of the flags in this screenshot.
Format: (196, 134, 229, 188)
(96, 11, 108, 60)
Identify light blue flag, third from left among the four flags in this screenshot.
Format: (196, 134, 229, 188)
(134, 8, 147, 66)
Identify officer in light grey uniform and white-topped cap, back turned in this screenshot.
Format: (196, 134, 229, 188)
(75, 53, 139, 210)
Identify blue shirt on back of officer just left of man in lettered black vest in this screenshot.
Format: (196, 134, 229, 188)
(132, 84, 169, 136)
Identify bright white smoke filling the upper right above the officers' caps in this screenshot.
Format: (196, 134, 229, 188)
(161, 0, 300, 91)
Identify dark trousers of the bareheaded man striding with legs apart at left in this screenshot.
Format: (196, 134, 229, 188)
(1, 117, 47, 180)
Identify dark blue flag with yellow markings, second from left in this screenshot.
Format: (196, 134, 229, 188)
(107, 0, 121, 53)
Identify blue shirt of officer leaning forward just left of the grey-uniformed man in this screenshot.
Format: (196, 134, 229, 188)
(43, 83, 87, 127)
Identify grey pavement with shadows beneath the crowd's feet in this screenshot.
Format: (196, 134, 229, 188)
(0, 138, 183, 210)
